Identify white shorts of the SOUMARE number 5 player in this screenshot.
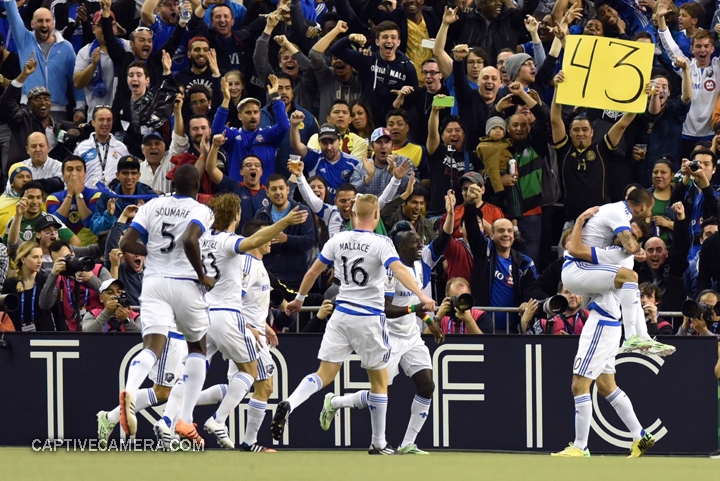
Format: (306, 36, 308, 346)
(140, 277, 208, 342)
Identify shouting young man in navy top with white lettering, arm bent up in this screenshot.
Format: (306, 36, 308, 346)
(330, 21, 418, 126)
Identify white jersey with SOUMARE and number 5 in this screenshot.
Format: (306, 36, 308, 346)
(130, 195, 215, 280)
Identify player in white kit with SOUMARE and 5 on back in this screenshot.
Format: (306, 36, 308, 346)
(114, 165, 215, 444)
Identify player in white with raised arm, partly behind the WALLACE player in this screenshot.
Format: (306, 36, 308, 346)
(320, 190, 455, 454)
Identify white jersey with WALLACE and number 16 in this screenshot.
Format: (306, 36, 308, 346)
(318, 230, 400, 311)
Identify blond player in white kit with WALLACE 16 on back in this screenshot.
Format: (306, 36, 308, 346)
(270, 194, 435, 454)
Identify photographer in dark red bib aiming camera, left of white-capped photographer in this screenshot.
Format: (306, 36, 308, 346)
(40, 240, 112, 331)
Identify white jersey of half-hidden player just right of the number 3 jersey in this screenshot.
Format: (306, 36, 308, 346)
(240, 254, 270, 334)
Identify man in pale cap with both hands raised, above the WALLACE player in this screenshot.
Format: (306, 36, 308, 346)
(350, 127, 415, 198)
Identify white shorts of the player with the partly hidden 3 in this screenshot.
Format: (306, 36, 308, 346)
(207, 309, 258, 364)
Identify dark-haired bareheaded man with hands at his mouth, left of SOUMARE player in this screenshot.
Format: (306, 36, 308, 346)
(45, 155, 100, 246)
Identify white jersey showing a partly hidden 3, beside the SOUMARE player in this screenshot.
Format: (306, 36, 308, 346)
(200, 229, 244, 312)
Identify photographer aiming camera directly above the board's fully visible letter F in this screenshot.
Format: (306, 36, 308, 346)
(434, 277, 493, 334)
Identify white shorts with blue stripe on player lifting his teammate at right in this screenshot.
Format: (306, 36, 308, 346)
(573, 310, 622, 380)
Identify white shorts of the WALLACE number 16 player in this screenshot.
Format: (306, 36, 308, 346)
(318, 306, 392, 370)
